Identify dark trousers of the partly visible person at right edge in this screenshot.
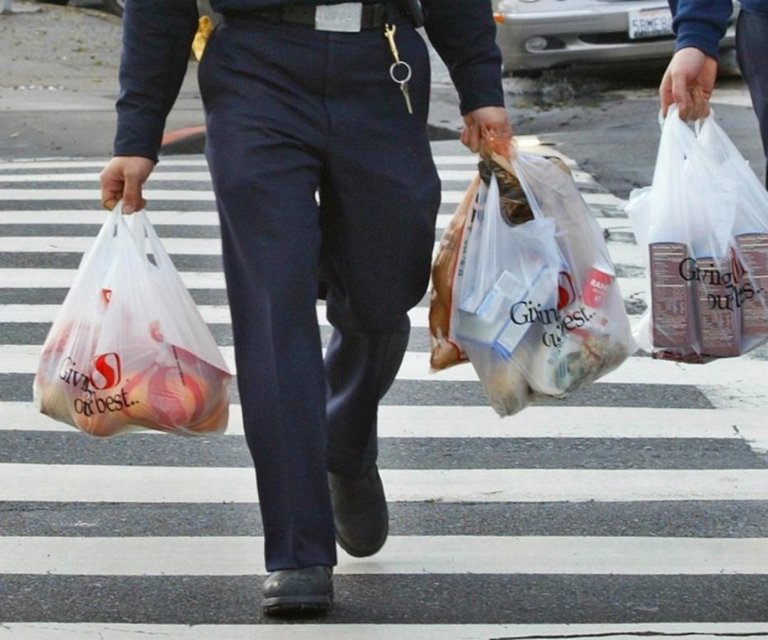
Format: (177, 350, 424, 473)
(736, 9, 768, 188)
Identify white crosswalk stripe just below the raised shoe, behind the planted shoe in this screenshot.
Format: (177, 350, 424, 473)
(0, 536, 768, 576)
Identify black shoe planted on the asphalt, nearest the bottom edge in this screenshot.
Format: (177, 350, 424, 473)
(261, 566, 333, 617)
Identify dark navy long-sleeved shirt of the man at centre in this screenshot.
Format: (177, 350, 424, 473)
(114, 0, 504, 160)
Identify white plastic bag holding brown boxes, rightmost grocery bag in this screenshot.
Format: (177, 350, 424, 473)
(626, 106, 768, 363)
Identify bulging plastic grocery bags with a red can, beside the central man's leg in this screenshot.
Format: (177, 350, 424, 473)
(430, 142, 635, 416)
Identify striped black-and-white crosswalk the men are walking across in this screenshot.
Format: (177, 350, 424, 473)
(0, 139, 768, 640)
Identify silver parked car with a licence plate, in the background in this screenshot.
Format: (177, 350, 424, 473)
(495, 0, 738, 75)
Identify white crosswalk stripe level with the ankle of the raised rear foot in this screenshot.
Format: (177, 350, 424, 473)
(0, 462, 768, 502)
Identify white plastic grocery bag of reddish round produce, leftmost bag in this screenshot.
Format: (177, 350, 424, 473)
(34, 204, 232, 436)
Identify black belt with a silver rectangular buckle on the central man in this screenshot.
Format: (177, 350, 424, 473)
(253, 2, 402, 32)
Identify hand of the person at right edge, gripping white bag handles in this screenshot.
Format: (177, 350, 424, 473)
(659, 47, 717, 120)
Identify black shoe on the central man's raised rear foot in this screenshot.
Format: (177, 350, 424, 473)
(328, 465, 389, 558)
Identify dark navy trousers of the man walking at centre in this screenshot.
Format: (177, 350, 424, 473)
(199, 15, 440, 571)
